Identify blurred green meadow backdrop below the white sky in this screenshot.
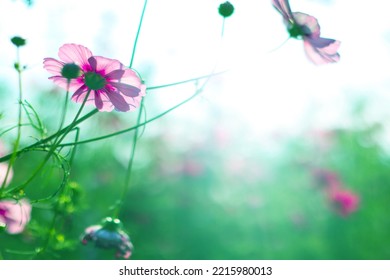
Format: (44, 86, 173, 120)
(0, 86, 390, 259)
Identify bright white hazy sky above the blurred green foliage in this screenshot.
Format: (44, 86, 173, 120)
(0, 0, 390, 139)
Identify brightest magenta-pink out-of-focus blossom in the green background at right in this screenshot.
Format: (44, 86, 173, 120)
(329, 189, 359, 216)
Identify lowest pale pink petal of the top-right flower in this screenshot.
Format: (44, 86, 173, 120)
(304, 38, 340, 65)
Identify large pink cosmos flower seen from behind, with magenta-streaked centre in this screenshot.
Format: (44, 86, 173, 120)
(43, 44, 146, 112)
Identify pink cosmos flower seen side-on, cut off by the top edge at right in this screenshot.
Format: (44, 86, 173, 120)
(272, 0, 340, 65)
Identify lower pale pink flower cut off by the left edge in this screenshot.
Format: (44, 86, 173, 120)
(0, 199, 31, 234)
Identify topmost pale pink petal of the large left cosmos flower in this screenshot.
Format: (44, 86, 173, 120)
(58, 44, 92, 66)
